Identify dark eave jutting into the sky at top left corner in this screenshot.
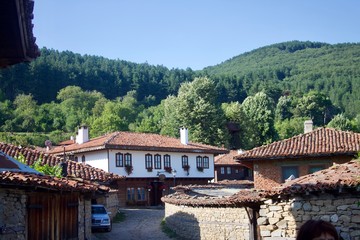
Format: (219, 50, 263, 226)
(0, 0, 40, 68)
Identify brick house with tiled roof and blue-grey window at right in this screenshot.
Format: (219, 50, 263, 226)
(235, 128, 360, 189)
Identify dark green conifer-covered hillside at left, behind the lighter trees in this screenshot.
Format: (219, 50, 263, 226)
(0, 48, 194, 105)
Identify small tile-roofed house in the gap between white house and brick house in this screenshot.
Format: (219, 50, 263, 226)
(214, 150, 252, 182)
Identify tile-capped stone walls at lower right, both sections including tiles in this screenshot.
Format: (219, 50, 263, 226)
(163, 160, 360, 240)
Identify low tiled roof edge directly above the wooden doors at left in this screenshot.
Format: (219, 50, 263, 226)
(0, 171, 109, 192)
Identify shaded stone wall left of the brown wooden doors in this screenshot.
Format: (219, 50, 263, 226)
(0, 188, 27, 240)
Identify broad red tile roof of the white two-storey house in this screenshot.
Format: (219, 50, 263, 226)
(49, 132, 228, 154)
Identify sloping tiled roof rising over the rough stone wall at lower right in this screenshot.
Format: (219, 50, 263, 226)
(275, 160, 360, 195)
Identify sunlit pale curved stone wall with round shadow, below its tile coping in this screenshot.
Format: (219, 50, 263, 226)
(165, 203, 250, 240)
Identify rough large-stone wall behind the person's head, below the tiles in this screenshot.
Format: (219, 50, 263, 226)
(257, 192, 360, 240)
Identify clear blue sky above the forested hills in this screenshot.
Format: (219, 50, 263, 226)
(33, 0, 360, 70)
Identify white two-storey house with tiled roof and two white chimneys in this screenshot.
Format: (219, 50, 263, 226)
(48, 126, 227, 205)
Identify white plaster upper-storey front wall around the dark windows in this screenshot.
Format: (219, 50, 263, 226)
(109, 150, 214, 178)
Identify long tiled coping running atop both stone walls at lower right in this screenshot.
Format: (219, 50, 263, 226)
(162, 160, 360, 207)
